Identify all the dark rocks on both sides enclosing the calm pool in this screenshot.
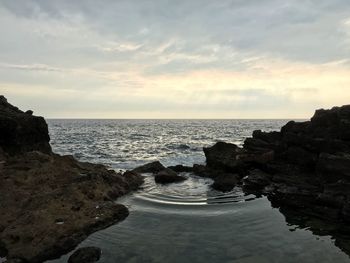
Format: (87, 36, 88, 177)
(0, 96, 350, 262)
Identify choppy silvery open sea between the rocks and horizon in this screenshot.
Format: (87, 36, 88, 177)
(48, 120, 287, 169)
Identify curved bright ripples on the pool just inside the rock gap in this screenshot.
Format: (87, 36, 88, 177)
(123, 173, 255, 216)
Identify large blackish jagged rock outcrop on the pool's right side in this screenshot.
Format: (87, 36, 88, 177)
(202, 106, 350, 226)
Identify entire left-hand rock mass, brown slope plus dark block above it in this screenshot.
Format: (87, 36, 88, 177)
(0, 97, 143, 262)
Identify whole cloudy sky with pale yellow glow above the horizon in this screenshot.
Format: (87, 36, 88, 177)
(0, 0, 350, 119)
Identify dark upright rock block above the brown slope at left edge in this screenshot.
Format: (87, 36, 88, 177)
(0, 96, 51, 154)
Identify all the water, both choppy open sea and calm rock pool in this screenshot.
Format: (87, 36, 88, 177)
(48, 120, 350, 263)
